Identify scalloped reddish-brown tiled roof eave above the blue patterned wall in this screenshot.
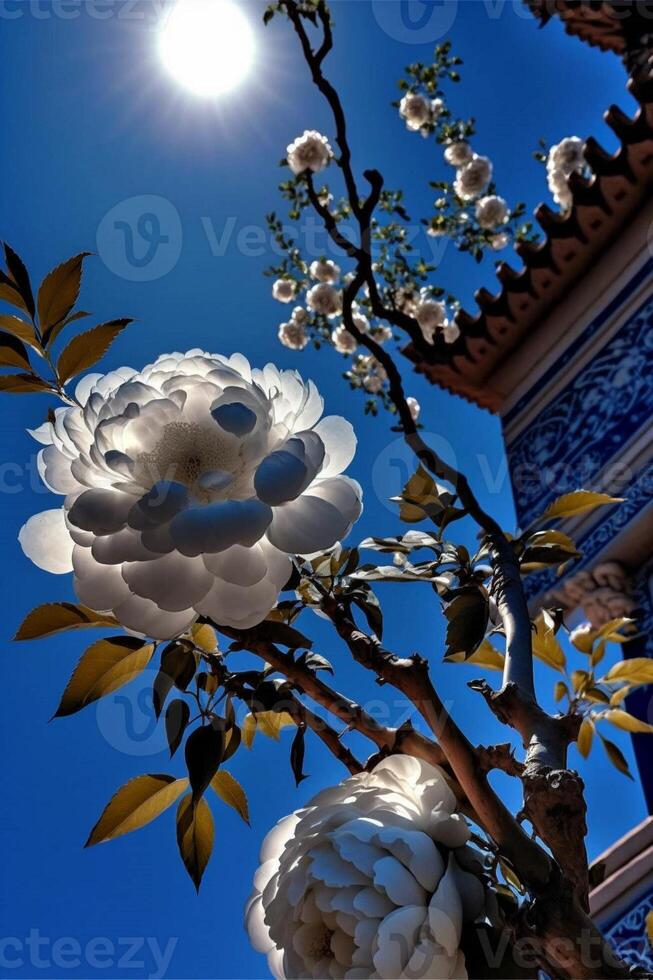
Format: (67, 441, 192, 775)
(404, 79, 653, 412)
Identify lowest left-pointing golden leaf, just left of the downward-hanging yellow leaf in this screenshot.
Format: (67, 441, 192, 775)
(84, 775, 188, 847)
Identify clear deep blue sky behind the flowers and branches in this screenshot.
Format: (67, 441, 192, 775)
(0, 0, 644, 978)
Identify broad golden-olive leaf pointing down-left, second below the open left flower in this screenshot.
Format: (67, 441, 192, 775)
(54, 636, 154, 718)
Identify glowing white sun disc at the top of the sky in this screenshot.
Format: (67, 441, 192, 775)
(159, 0, 254, 98)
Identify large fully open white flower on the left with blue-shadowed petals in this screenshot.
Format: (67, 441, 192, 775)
(20, 350, 361, 638)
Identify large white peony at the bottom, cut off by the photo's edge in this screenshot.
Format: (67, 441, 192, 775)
(246, 756, 486, 980)
